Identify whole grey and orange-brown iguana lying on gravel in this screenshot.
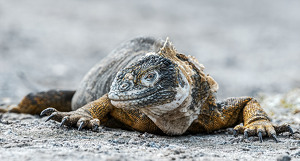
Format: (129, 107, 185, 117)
(2, 37, 293, 142)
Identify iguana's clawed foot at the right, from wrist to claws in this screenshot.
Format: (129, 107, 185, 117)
(234, 120, 293, 142)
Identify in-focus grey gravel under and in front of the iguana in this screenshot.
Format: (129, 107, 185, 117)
(0, 89, 300, 161)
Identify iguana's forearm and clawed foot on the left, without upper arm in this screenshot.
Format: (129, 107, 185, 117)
(41, 94, 114, 130)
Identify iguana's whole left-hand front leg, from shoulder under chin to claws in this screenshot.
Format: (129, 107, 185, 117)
(41, 94, 163, 134)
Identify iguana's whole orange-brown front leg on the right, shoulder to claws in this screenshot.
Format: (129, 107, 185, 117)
(192, 97, 293, 142)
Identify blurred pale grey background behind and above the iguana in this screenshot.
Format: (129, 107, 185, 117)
(0, 0, 300, 104)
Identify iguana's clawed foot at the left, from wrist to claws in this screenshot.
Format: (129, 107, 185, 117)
(40, 107, 100, 131)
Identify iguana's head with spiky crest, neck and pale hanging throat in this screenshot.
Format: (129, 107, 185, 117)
(108, 39, 217, 134)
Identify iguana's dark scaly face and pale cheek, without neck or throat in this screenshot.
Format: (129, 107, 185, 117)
(109, 38, 190, 110)
